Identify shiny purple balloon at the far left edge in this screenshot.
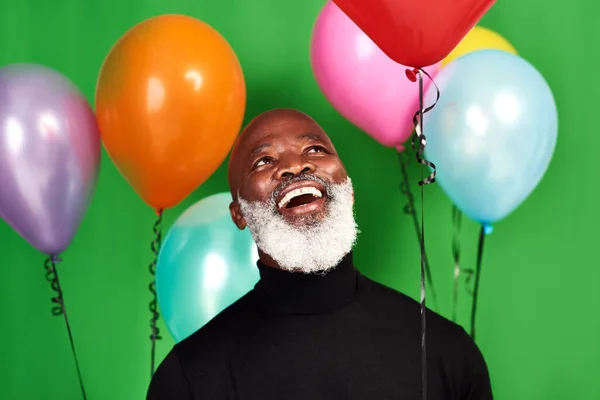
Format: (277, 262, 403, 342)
(0, 64, 100, 255)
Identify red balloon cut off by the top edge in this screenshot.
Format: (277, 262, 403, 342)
(333, 0, 496, 68)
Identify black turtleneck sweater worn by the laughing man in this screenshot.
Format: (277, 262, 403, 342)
(147, 255, 492, 400)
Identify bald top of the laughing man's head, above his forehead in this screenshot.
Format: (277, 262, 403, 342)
(228, 108, 345, 200)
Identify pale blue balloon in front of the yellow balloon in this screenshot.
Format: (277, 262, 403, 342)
(424, 50, 558, 225)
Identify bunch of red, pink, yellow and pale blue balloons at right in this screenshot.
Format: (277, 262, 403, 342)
(311, 0, 558, 228)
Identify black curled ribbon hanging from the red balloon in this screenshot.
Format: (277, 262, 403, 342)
(407, 69, 440, 400)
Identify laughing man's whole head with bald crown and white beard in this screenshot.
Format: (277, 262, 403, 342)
(229, 112, 358, 273)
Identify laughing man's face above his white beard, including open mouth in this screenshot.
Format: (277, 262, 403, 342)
(237, 117, 348, 224)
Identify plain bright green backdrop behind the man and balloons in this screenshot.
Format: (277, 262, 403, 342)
(0, 0, 600, 400)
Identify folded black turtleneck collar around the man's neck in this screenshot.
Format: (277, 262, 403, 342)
(254, 253, 361, 314)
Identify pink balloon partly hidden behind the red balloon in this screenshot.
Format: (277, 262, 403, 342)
(310, 1, 439, 151)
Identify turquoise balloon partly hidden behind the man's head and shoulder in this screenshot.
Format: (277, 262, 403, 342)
(156, 193, 259, 342)
